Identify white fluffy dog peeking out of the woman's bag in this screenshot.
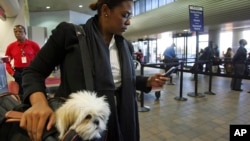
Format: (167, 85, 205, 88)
(56, 91, 110, 140)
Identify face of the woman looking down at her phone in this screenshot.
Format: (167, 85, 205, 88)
(107, 1, 133, 35)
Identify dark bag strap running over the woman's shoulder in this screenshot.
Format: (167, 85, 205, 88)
(74, 24, 94, 91)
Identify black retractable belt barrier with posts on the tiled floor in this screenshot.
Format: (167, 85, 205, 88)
(139, 58, 250, 112)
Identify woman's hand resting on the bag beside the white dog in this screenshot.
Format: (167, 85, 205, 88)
(20, 92, 55, 141)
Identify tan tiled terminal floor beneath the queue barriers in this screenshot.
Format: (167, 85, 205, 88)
(138, 69, 250, 141)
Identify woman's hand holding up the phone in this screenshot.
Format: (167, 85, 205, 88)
(147, 73, 169, 87)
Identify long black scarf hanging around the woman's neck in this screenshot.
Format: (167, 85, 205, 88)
(85, 16, 139, 141)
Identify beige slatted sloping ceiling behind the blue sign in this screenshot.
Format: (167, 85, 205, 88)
(124, 0, 250, 38)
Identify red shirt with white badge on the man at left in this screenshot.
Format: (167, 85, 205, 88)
(5, 39, 40, 75)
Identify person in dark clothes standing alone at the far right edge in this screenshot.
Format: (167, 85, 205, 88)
(231, 39, 247, 91)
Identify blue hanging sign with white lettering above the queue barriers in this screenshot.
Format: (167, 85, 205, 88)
(189, 5, 204, 32)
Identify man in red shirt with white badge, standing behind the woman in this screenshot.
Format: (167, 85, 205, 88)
(5, 25, 40, 98)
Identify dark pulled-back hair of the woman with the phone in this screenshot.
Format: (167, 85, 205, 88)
(89, 0, 133, 14)
